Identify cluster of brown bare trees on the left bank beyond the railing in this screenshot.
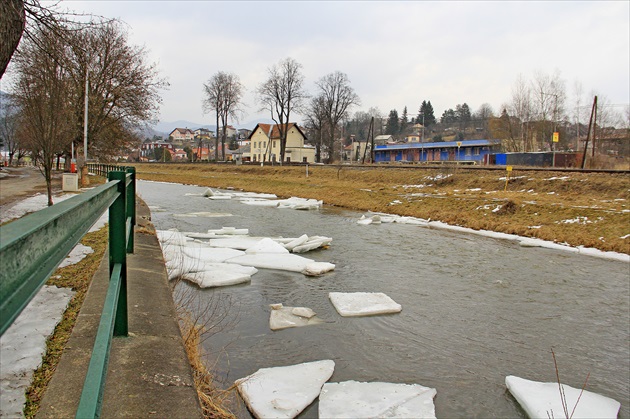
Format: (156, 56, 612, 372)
(2, 11, 168, 205)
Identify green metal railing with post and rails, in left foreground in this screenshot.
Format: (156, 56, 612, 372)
(0, 167, 136, 417)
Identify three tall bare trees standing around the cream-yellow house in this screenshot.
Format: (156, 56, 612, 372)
(202, 58, 361, 162)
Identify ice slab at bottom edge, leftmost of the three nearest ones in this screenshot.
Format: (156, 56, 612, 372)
(236, 360, 335, 418)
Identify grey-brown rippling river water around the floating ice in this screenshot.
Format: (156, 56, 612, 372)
(138, 181, 630, 418)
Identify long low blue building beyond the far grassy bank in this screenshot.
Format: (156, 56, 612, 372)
(374, 140, 501, 163)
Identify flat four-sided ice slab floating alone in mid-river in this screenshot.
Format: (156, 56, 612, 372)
(328, 292, 402, 317)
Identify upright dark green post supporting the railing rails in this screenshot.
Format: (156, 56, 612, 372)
(108, 171, 128, 336)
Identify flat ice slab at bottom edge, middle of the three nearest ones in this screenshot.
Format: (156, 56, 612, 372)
(319, 381, 437, 418)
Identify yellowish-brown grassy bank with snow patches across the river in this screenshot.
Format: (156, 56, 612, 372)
(136, 164, 630, 254)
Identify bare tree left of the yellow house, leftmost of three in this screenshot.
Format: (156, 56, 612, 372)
(202, 71, 244, 161)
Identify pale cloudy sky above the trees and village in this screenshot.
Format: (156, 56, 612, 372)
(32, 0, 630, 124)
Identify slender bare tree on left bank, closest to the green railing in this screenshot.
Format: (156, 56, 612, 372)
(15, 27, 73, 206)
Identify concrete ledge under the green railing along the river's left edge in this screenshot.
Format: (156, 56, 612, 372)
(37, 200, 202, 418)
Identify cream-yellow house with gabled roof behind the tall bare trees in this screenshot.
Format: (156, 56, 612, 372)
(249, 122, 315, 163)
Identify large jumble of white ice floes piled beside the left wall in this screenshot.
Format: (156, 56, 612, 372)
(156, 227, 335, 288)
